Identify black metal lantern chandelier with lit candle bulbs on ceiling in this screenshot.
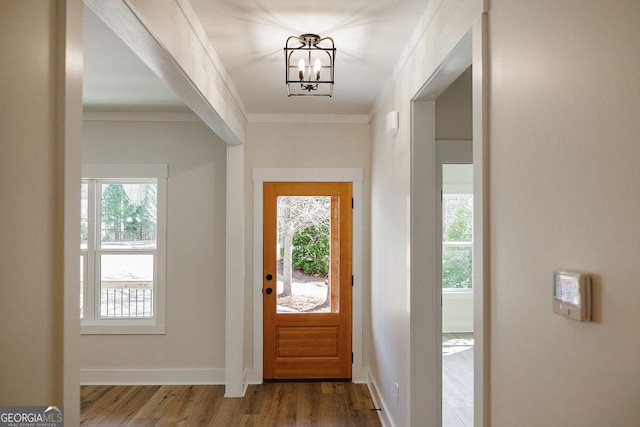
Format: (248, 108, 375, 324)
(284, 34, 336, 96)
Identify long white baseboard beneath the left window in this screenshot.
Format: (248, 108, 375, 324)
(80, 368, 224, 385)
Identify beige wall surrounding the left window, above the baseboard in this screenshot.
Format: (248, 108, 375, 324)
(81, 115, 226, 383)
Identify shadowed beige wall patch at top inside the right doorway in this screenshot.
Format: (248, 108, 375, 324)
(436, 67, 473, 140)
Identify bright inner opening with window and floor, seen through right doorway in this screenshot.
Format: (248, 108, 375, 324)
(436, 159, 474, 427)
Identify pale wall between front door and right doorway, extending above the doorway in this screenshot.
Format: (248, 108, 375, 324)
(370, 0, 483, 426)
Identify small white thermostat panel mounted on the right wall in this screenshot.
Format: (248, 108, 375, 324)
(553, 270, 591, 322)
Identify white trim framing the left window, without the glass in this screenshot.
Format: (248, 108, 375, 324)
(80, 164, 169, 335)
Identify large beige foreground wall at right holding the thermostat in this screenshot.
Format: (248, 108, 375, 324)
(489, 0, 640, 427)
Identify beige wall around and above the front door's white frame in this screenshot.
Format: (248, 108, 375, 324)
(245, 120, 370, 382)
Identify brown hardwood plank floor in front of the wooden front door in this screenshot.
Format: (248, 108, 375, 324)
(80, 382, 380, 427)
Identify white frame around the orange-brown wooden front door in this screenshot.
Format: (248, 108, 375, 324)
(247, 168, 367, 384)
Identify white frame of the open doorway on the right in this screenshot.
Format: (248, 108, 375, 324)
(410, 14, 490, 427)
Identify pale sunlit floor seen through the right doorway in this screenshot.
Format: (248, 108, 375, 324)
(442, 333, 474, 427)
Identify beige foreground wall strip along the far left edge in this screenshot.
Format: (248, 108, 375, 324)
(0, 1, 63, 405)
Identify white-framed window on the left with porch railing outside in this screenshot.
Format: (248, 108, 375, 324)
(80, 165, 167, 334)
